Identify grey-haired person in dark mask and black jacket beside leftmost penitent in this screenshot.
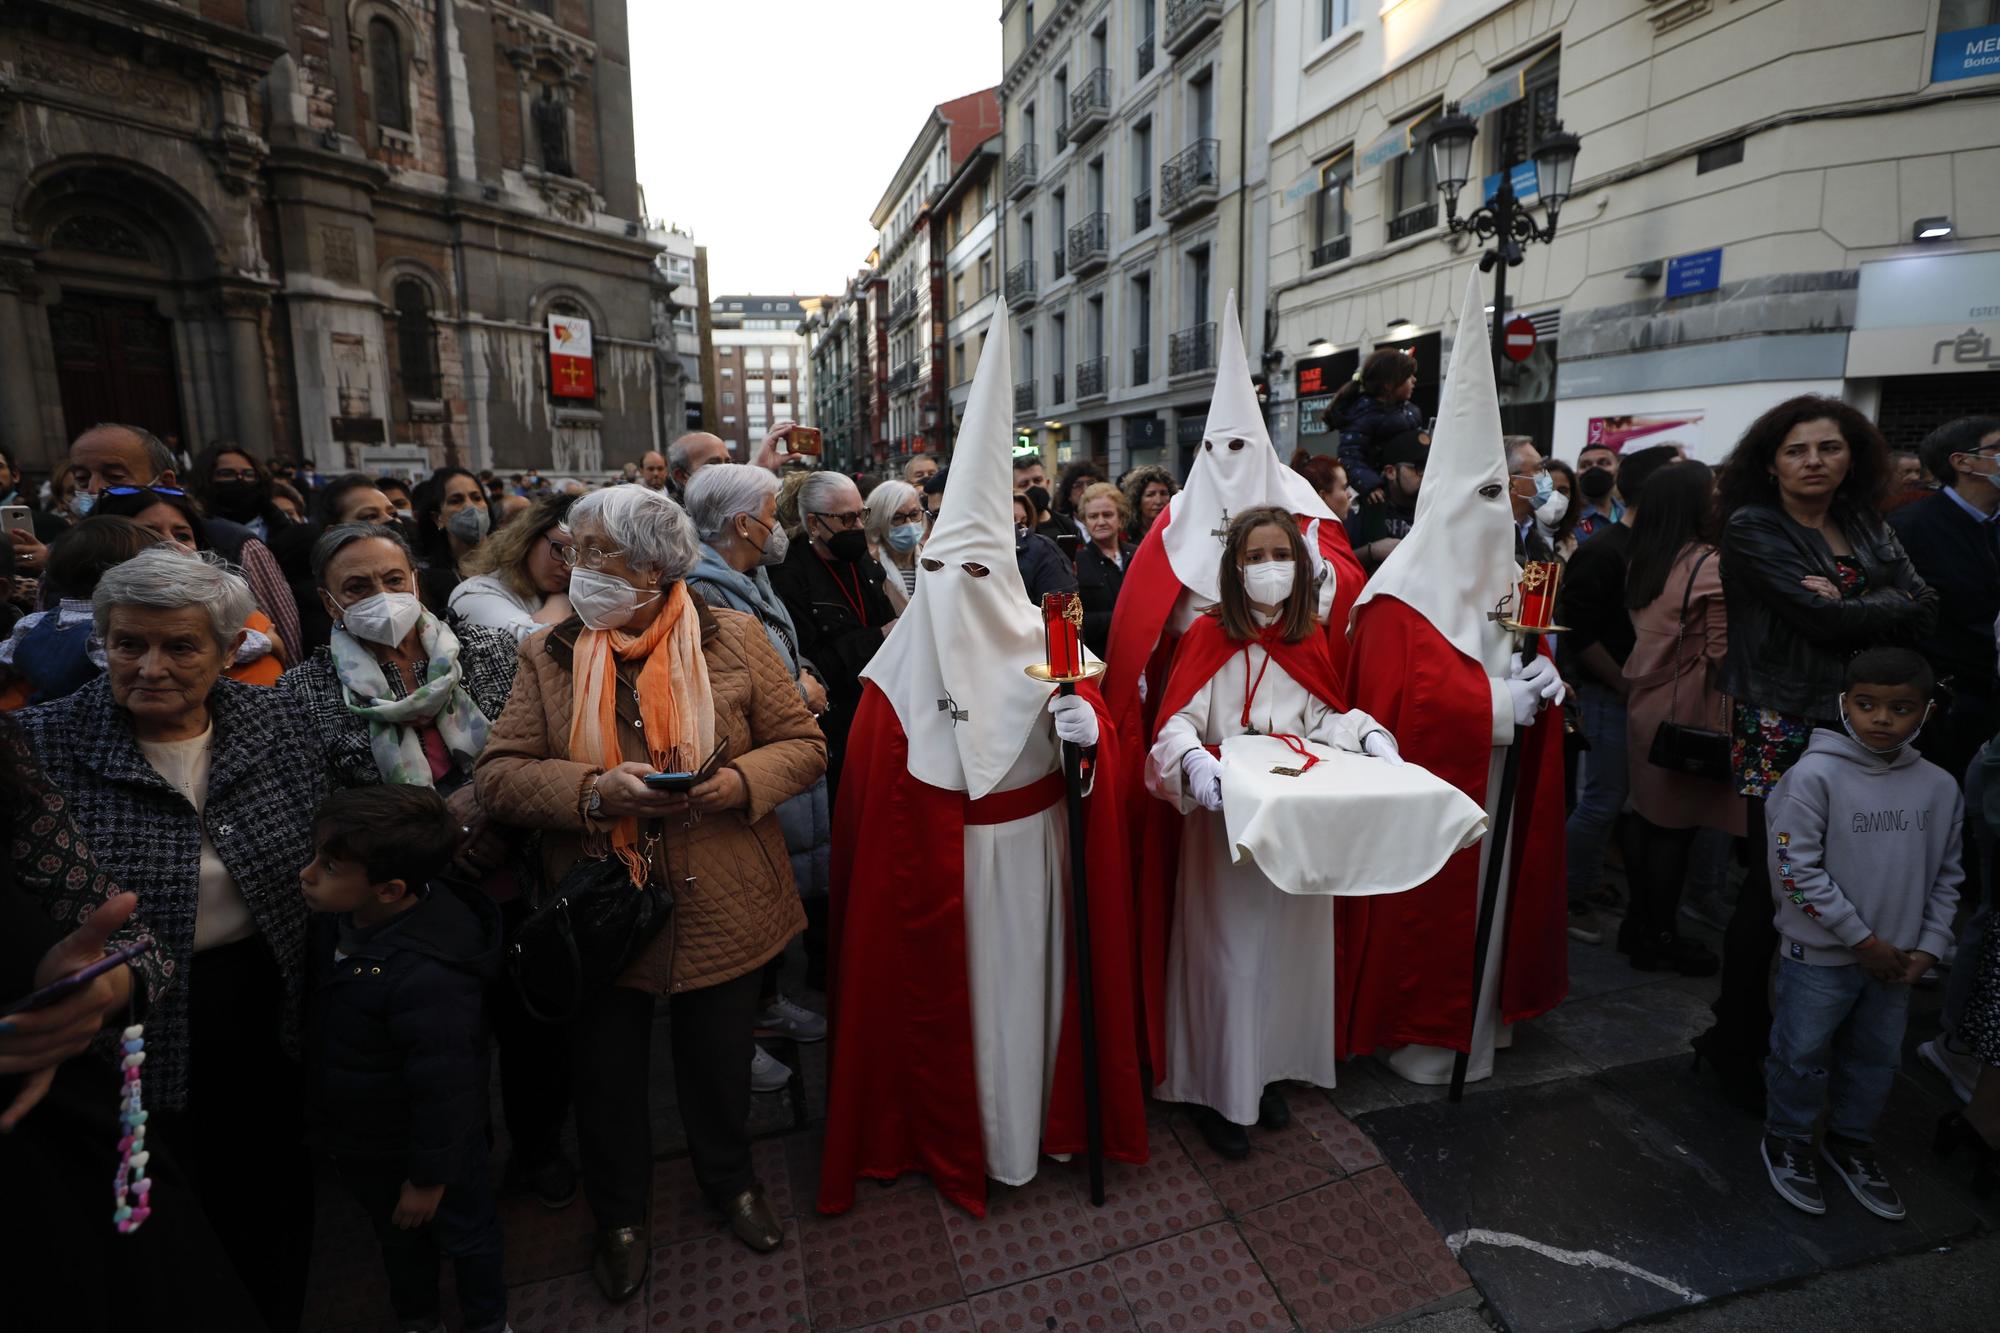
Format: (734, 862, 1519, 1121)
(770, 472, 896, 803)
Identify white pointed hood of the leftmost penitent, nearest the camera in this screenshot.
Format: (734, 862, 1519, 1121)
(862, 308, 1054, 799)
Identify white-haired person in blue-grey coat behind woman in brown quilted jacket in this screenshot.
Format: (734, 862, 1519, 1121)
(686, 462, 834, 1024)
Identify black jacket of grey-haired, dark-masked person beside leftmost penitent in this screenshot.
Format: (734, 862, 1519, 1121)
(770, 536, 896, 781)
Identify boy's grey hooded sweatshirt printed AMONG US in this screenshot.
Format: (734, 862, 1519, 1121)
(1764, 727, 1964, 967)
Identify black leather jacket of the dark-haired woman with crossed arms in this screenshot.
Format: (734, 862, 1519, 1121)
(1722, 504, 1936, 723)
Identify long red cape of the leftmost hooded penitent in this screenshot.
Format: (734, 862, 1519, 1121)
(818, 683, 1146, 1217)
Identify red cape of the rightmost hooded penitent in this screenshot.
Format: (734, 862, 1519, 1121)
(1334, 596, 1570, 1059)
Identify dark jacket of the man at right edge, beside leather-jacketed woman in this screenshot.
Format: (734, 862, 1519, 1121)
(1888, 490, 2000, 699)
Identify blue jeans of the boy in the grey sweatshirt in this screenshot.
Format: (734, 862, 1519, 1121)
(1764, 956, 1910, 1143)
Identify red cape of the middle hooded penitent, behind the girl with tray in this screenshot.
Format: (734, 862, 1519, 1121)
(1098, 510, 1366, 1075)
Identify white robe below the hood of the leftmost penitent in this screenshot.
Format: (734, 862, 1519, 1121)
(966, 721, 1070, 1185)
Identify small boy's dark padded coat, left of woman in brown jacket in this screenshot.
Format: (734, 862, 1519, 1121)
(306, 883, 500, 1185)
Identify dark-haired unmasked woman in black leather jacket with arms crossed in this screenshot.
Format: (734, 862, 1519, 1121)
(1694, 394, 1936, 1103)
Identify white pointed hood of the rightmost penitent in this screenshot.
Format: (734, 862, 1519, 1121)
(1360, 268, 1520, 677)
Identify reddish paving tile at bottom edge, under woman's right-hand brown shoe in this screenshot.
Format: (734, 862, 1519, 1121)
(648, 1223, 808, 1333)
